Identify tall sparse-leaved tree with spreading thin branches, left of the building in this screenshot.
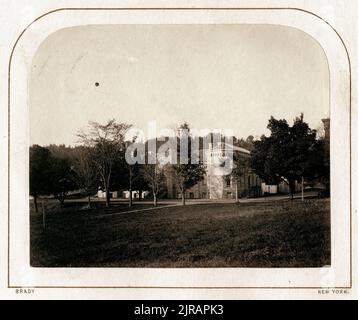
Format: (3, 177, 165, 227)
(78, 119, 130, 207)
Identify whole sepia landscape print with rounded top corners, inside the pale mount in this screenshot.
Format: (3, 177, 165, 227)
(28, 24, 331, 268)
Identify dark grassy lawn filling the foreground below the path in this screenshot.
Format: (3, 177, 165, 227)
(30, 199, 330, 267)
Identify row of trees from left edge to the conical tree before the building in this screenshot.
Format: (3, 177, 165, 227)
(30, 119, 205, 211)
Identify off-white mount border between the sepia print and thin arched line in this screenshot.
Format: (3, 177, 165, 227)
(10, 9, 350, 288)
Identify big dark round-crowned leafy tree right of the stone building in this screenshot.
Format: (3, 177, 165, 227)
(251, 114, 323, 199)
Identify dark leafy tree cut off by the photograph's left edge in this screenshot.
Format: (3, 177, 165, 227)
(30, 145, 52, 212)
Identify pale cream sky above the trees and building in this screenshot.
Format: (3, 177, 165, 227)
(29, 25, 329, 145)
